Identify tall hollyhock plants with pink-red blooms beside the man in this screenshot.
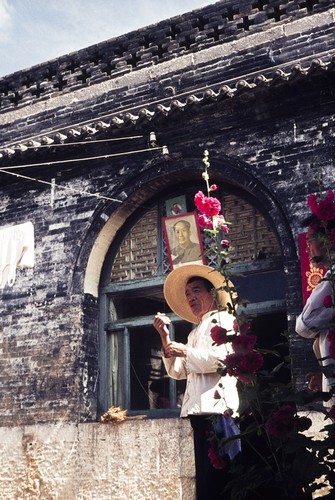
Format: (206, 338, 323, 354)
(194, 151, 335, 500)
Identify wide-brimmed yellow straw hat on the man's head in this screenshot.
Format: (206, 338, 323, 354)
(163, 264, 230, 324)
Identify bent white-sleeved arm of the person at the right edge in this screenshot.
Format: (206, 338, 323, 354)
(296, 280, 335, 338)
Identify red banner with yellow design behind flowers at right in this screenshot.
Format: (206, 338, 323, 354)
(299, 233, 326, 304)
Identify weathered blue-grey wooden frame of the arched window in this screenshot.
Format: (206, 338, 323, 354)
(97, 186, 287, 418)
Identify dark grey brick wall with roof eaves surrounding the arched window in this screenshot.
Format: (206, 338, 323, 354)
(0, 2, 335, 434)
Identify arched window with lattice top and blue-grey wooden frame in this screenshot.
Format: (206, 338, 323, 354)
(98, 186, 286, 418)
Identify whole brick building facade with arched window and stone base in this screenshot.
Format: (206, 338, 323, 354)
(0, 0, 335, 500)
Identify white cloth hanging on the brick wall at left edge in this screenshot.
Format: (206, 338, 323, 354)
(0, 222, 34, 289)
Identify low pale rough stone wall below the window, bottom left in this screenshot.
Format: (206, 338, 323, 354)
(0, 419, 194, 500)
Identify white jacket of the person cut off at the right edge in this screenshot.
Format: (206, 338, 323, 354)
(295, 271, 335, 406)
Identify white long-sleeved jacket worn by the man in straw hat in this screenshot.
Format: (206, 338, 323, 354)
(163, 311, 238, 417)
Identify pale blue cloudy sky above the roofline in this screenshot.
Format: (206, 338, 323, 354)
(0, 0, 213, 77)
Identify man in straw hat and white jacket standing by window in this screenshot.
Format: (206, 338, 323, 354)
(153, 264, 238, 500)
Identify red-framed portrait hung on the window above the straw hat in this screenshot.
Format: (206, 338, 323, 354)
(163, 212, 206, 270)
